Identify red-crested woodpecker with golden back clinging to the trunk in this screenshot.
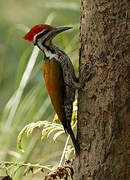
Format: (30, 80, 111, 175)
(24, 24, 81, 153)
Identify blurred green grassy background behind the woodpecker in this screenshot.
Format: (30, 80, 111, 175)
(0, 0, 80, 180)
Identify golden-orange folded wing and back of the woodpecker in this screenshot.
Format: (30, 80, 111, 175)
(43, 59, 65, 122)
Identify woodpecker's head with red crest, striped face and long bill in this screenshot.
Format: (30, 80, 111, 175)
(24, 24, 71, 45)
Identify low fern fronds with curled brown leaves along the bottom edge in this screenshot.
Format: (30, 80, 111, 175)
(0, 161, 73, 180)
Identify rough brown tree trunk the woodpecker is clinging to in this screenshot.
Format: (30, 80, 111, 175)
(74, 0, 130, 180)
